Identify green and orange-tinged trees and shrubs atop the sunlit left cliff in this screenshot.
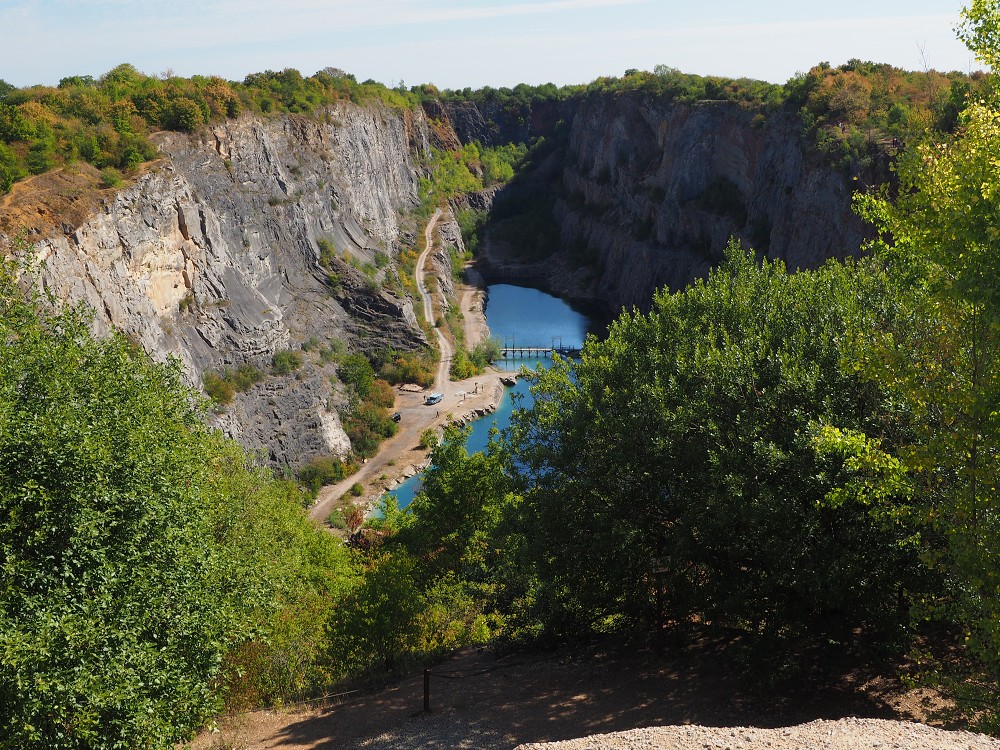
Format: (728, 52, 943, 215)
(0, 64, 417, 190)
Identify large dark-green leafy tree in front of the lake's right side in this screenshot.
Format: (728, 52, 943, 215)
(504, 247, 924, 653)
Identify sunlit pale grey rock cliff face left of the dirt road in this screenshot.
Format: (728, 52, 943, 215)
(22, 103, 427, 466)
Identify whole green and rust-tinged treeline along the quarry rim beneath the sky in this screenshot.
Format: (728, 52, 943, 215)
(0, 60, 986, 193)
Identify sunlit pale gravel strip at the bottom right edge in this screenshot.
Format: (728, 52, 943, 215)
(517, 719, 1000, 750)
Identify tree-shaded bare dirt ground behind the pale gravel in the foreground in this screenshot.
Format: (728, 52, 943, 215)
(248, 638, 919, 750)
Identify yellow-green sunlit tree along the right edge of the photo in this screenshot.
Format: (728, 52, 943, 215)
(859, 91, 1000, 730)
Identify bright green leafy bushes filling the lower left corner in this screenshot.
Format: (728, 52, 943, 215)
(0, 266, 356, 750)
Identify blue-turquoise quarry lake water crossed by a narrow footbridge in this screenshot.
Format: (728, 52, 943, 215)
(388, 284, 603, 508)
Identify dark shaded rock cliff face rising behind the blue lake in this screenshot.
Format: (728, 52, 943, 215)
(480, 95, 866, 312)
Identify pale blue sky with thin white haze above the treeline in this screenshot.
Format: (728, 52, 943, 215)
(0, 0, 980, 89)
